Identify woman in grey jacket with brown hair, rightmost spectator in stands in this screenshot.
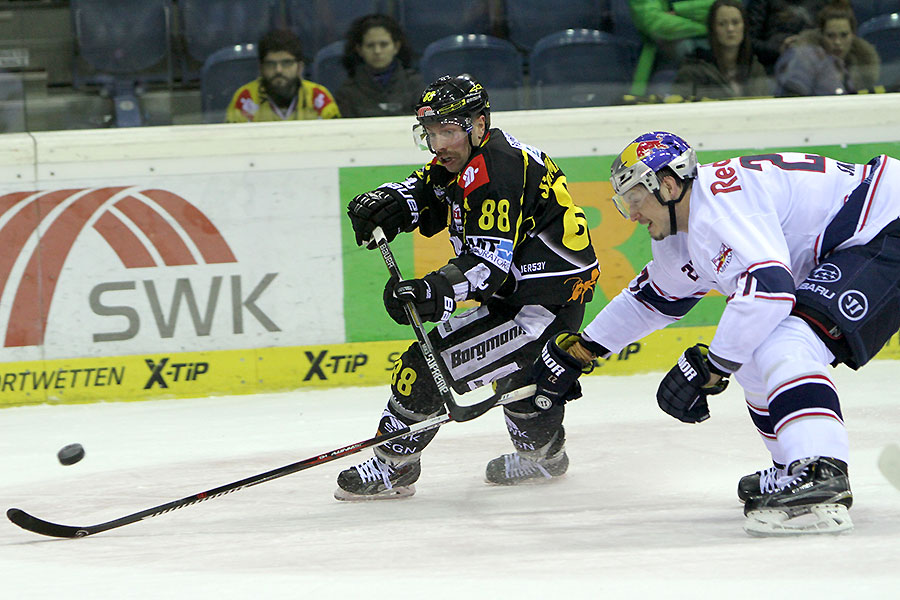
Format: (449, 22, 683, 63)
(775, 0, 881, 96)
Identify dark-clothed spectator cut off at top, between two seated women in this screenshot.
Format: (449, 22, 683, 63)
(747, 0, 829, 74)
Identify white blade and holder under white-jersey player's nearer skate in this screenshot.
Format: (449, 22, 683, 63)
(744, 504, 853, 537)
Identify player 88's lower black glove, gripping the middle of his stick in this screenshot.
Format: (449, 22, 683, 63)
(384, 272, 456, 325)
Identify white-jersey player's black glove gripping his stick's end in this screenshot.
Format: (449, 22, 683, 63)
(531, 332, 593, 410)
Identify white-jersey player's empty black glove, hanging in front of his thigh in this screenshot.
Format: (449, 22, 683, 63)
(656, 344, 728, 423)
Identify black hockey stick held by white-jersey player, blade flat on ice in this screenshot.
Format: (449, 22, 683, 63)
(6, 385, 535, 538)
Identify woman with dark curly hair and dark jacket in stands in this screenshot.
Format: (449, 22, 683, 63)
(336, 14, 425, 117)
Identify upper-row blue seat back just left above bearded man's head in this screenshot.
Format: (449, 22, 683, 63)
(178, 0, 280, 80)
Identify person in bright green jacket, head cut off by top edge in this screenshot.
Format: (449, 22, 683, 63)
(628, 0, 713, 96)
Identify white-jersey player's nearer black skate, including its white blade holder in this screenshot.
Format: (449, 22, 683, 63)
(744, 456, 853, 536)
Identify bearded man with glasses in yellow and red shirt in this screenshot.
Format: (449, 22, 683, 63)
(225, 30, 341, 123)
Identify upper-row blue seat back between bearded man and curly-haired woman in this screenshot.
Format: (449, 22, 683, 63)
(285, 0, 387, 61)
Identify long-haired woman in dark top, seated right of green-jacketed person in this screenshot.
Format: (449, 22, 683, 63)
(672, 0, 772, 100)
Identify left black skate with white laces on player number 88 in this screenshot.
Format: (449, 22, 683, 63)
(334, 455, 422, 501)
